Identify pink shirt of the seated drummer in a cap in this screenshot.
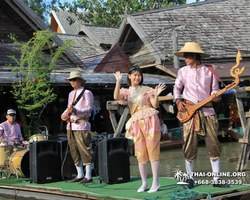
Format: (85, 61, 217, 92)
(0, 120, 23, 146)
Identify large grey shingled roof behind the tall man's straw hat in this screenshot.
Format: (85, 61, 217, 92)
(114, 0, 250, 77)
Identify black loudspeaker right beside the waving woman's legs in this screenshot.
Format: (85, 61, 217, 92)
(98, 138, 130, 184)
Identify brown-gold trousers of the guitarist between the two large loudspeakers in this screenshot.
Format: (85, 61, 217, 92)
(67, 130, 93, 165)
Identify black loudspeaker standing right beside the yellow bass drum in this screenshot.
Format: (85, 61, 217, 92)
(30, 140, 62, 183)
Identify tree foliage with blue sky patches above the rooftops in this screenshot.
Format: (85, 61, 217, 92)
(24, 0, 186, 27)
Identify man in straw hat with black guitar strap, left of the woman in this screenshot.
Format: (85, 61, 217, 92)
(61, 72, 94, 183)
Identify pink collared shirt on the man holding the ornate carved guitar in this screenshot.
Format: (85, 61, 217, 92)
(173, 64, 219, 116)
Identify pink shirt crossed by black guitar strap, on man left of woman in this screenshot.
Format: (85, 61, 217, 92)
(62, 87, 94, 131)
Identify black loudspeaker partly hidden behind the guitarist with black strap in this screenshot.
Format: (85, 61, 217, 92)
(59, 140, 77, 180)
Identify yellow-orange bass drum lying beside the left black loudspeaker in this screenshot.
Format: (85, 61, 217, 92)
(10, 149, 30, 178)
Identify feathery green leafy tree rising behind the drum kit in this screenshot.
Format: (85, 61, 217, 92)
(9, 30, 72, 136)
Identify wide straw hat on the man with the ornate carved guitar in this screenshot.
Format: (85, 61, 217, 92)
(174, 42, 209, 58)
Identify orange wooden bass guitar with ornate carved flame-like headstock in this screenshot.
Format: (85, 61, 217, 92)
(177, 51, 245, 123)
